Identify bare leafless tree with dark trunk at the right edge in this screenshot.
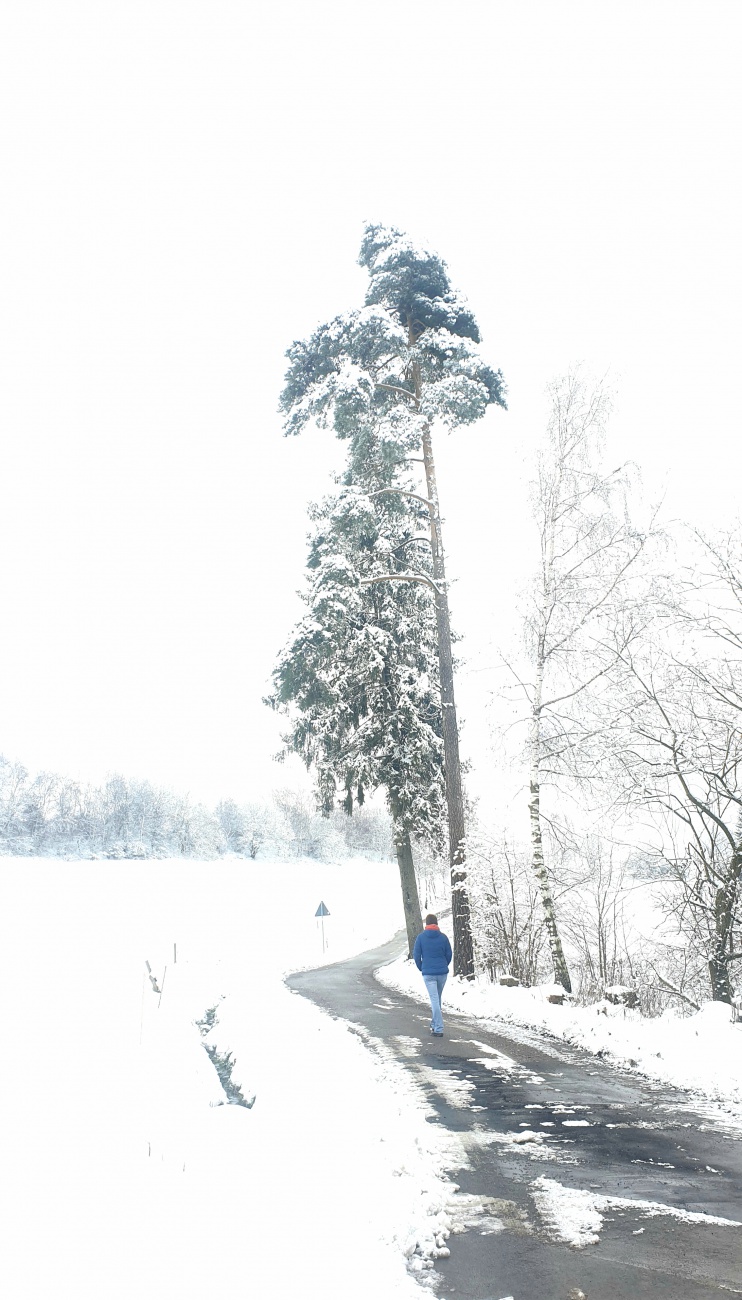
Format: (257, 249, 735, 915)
(616, 532, 742, 1002)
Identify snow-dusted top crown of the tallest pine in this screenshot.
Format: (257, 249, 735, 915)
(281, 226, 505, 449)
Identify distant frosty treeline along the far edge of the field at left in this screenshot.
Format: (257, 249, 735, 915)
(0, 755, 391, 862)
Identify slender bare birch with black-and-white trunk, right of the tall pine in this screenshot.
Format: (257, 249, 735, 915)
(508, 369, 646, 992)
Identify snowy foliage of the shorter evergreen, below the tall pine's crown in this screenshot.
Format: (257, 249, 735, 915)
(269, 460, 444, 848)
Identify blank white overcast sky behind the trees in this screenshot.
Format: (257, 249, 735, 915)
(0, 0, 742, 801)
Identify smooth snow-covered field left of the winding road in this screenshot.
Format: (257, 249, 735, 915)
(0, 859, 455, 1300)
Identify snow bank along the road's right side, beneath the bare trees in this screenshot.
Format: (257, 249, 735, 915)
(377, 957, 742, 1121)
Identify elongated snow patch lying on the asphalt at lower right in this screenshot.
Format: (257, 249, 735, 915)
(530, 1178, 742, 1249)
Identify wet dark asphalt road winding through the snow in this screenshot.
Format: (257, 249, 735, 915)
(287, 939, 742, 1300)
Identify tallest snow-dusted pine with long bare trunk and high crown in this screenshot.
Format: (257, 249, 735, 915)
(281, 225, 505, 976)
